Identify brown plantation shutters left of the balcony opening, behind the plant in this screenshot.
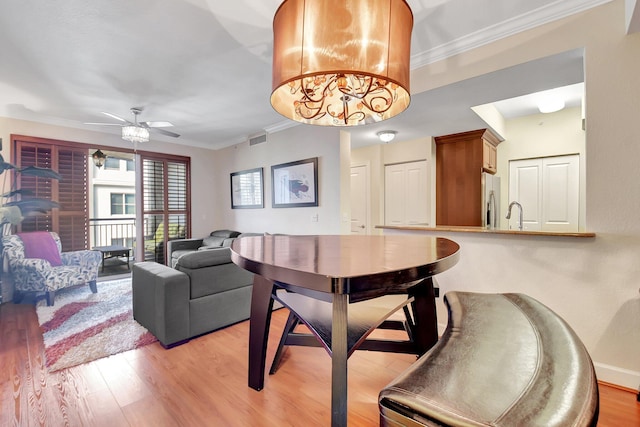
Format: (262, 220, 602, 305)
(12, 137, 89, 251)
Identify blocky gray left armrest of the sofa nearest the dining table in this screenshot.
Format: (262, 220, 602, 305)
(131, 262, 191, 348)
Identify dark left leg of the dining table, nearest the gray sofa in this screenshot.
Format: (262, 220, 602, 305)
(249, 274, 274, 391)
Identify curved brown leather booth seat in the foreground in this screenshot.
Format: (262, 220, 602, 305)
(378, 292, 599, 427)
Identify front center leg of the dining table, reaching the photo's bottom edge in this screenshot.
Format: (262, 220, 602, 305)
(331, 294, 349, 427)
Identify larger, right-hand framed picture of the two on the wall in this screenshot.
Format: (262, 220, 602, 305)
(271, 157, 318, 208)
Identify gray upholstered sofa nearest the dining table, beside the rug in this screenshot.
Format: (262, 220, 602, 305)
(132, 233, 259, 348)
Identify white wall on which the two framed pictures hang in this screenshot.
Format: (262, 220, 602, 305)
(212, 125, 351, 234)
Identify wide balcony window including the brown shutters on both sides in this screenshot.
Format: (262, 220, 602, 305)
(11, 135, 191, 262)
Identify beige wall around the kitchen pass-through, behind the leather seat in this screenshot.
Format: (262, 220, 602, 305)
(390, 0, 640, 389)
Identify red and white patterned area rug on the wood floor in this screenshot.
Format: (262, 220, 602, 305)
(36, 279, 157, 372)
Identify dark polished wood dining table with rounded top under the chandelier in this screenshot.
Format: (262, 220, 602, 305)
(231, 234, 460, 427)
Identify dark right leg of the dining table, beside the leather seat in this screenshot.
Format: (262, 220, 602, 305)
(409, 277, 438, 355)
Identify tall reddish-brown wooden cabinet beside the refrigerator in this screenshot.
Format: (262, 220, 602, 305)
(435, 129, 500, 227)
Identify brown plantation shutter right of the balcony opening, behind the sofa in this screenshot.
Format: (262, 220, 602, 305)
(141, 154, 191, 264)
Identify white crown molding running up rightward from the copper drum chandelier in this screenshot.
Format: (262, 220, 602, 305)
(411, 0, 612, 69)
